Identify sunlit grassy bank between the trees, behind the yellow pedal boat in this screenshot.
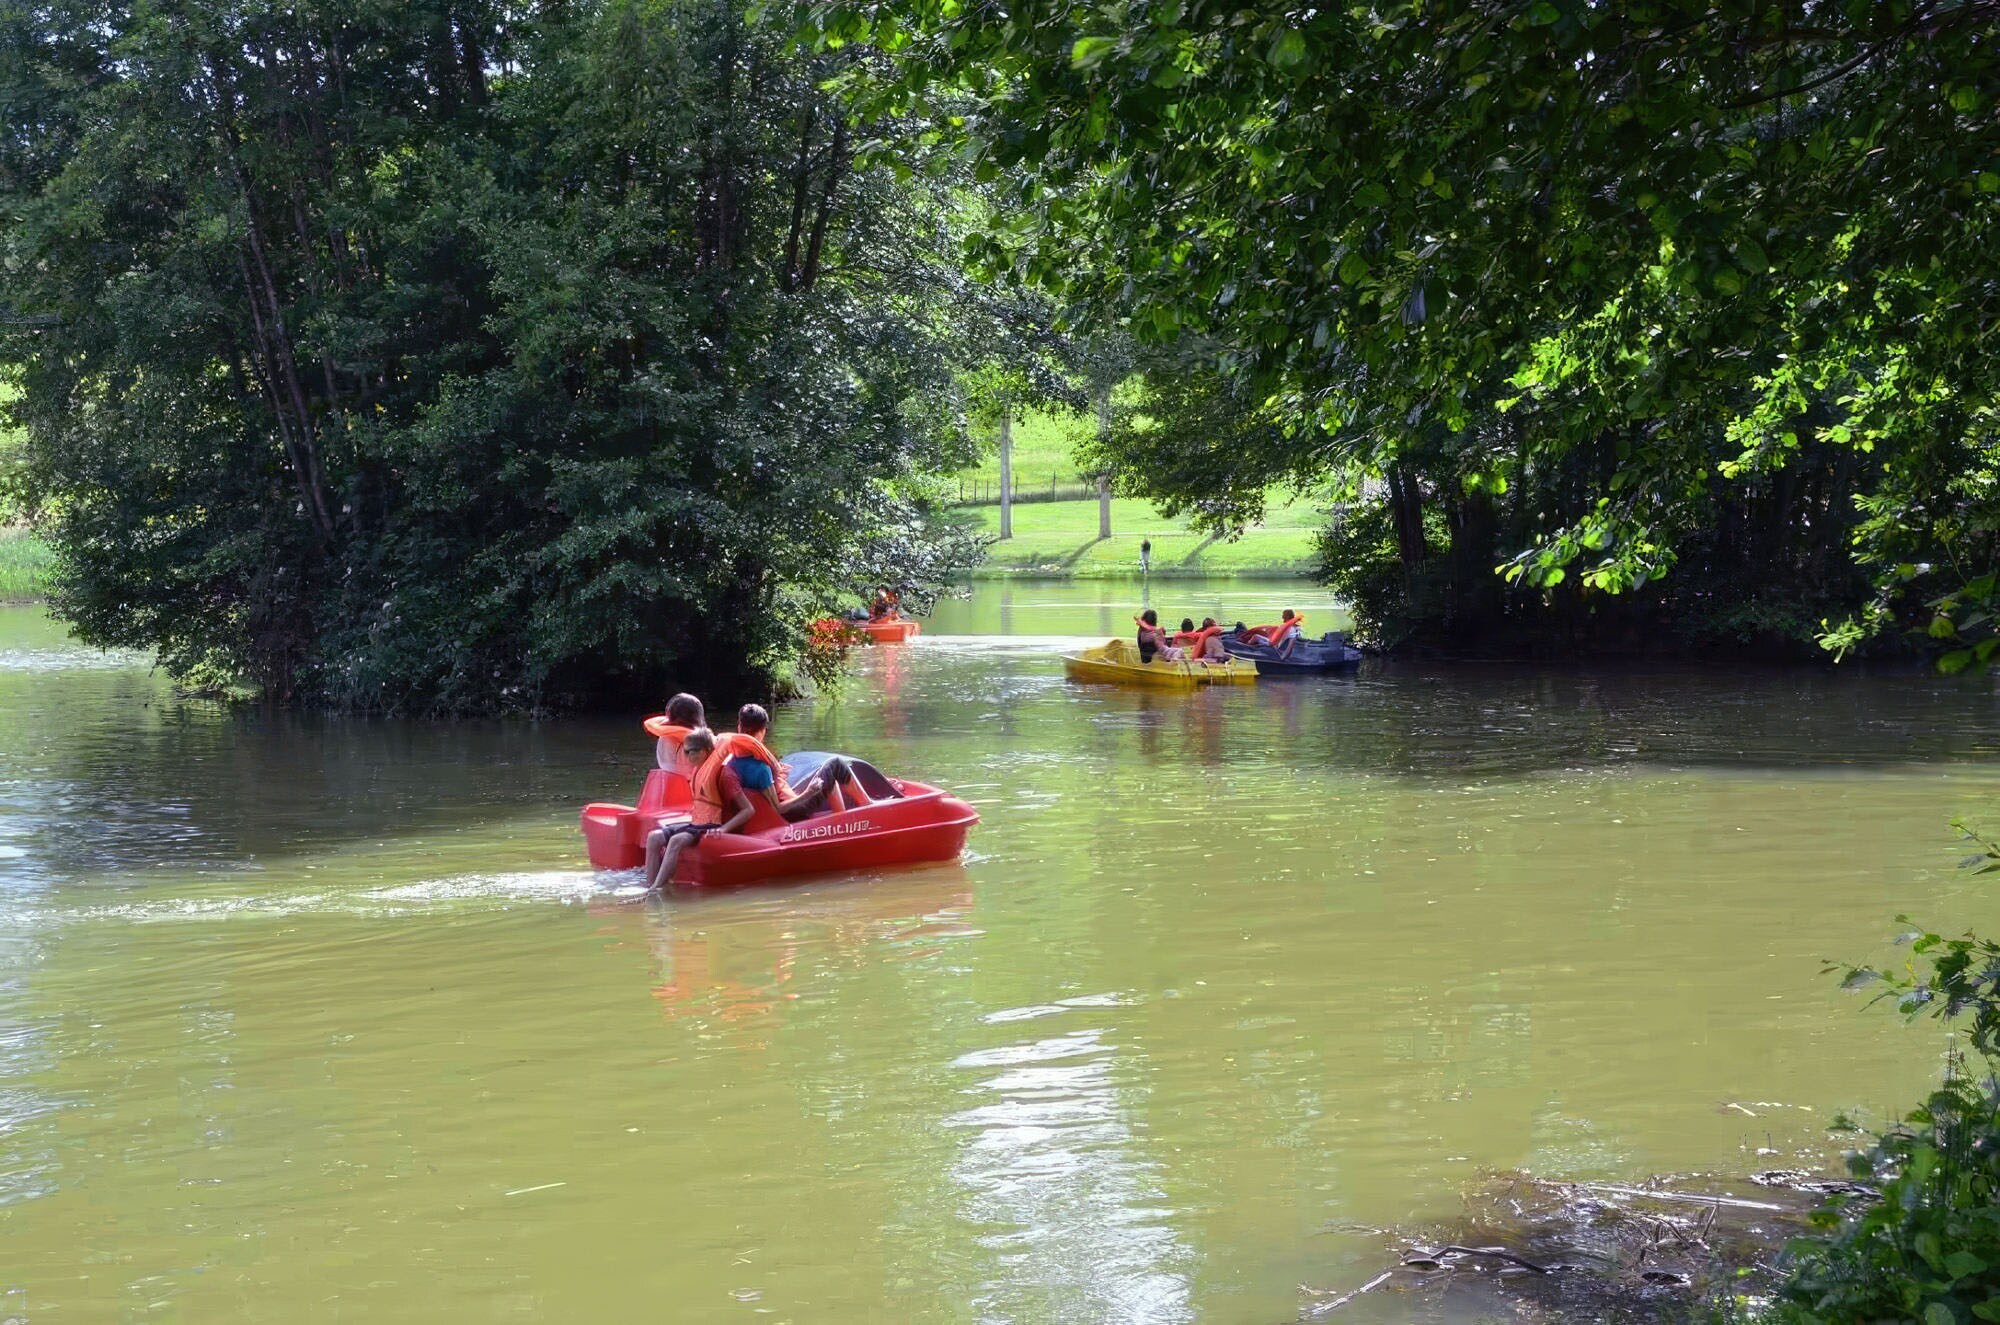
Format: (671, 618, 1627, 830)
(964, 498, 1320, 578)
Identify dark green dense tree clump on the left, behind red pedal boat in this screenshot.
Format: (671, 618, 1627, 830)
(0, 0, 1000, 711)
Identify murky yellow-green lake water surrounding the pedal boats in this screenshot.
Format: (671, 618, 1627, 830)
(0, 584, 2000, 1323)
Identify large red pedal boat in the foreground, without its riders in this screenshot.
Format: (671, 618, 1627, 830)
(580, 755, 980, 887)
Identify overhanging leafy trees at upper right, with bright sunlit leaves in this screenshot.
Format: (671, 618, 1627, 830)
(804, 0, 2000, 658)
